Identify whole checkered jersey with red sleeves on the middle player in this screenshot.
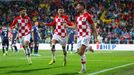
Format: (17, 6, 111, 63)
(47, 15, 72, 38)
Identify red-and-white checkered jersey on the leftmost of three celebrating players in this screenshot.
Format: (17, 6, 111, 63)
(10, 16, 32, 38)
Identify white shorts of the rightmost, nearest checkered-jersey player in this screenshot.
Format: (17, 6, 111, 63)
(77, 36, 91, 49)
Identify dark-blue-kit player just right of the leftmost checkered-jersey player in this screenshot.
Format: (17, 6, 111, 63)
(32, 21, 41, 56)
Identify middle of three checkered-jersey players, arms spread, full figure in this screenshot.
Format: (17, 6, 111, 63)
(44, 6, 71, 66)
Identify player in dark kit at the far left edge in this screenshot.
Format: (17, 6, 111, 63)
(1, 25, 9, 56)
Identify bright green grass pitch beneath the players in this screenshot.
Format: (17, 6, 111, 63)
(0, 50, 134, 75)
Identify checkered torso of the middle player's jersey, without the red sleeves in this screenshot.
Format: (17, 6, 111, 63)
(55, 17, 66, 38)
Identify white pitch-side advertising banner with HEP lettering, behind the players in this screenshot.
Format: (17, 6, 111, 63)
(0, 44, 134, 51)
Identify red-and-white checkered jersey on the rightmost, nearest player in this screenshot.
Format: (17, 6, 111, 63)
(76, 12, 93, 37)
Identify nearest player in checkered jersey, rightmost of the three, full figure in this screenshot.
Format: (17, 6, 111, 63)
(64, 2, 97, 73)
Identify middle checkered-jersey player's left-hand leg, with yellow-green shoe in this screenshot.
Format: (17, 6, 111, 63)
(49, 34, 59, 65)
